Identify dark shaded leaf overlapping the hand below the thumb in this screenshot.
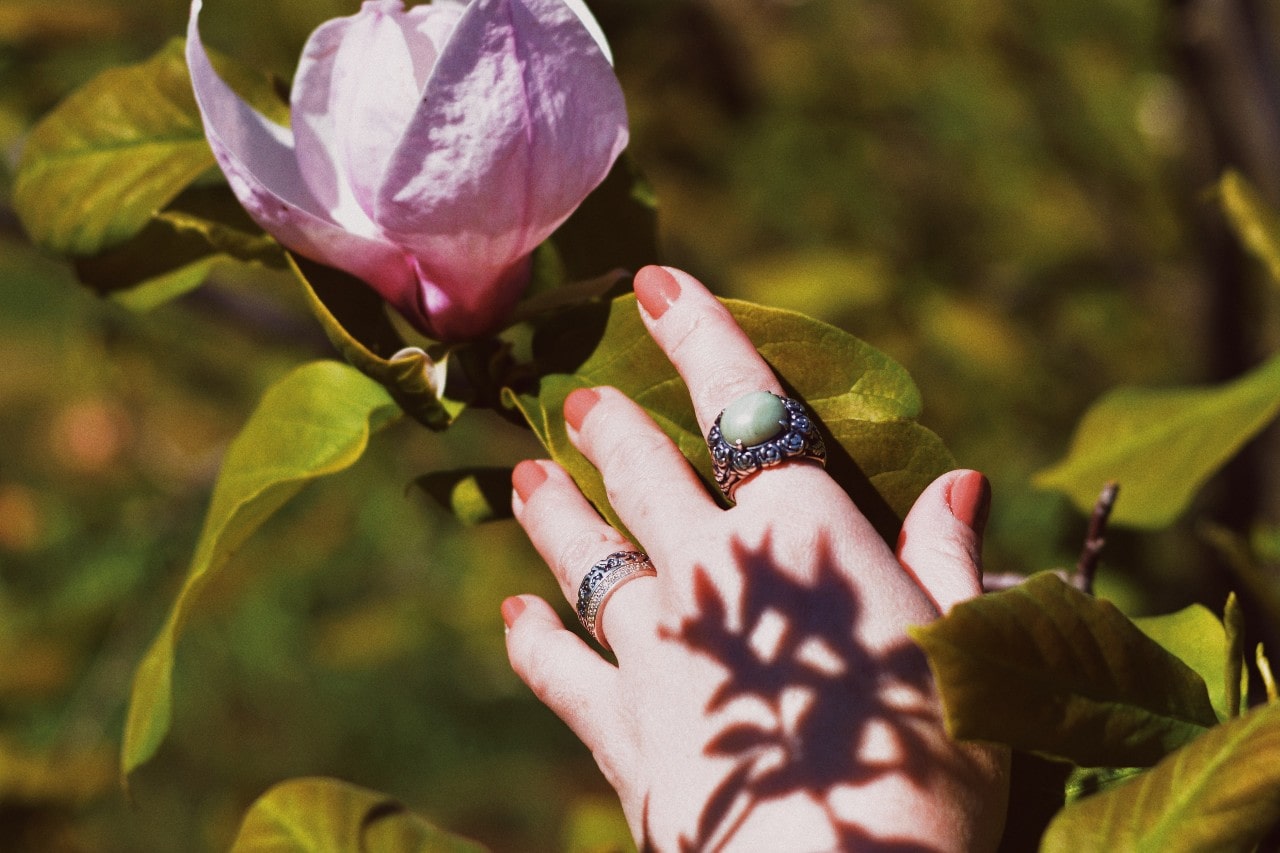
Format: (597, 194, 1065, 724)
(910, 573, 1217, 767)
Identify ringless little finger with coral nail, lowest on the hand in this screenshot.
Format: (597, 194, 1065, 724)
(502, 596, 628, 775)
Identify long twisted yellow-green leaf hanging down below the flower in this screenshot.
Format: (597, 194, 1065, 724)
(122, 361, 398, 775)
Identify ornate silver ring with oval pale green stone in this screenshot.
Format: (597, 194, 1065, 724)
(707, 391, 827, 500)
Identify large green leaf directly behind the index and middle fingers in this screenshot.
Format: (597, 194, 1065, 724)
(506, 295, 954, 539)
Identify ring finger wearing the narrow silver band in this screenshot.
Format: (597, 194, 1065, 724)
(511, 460, 658, 654)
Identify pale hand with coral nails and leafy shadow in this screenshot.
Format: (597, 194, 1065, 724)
(503, 268, 1007, 850)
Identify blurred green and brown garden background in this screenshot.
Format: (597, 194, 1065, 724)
(0, 0, 1280, 852)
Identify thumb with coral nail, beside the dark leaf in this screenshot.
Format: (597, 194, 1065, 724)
(897, 470, 991, 613)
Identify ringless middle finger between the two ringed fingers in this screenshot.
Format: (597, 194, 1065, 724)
(564, 387, 719, 556)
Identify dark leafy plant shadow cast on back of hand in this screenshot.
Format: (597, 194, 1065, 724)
(646, 539, 964, 852)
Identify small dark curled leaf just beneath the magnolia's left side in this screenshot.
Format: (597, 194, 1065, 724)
(287, 252, 462, 429)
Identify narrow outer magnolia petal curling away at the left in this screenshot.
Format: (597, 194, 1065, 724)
(187, 0, 417, 314)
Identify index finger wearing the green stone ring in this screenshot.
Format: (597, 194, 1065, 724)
(635, 266, 837, 502)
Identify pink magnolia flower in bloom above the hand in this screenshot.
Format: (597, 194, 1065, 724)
(187, 0, 627, 339)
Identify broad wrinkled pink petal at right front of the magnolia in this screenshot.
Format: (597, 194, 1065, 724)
(374, 0, 627, 289)
